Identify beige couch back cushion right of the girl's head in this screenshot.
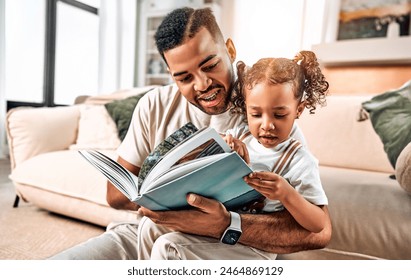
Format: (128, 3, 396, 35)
(298, 95, 394, 173)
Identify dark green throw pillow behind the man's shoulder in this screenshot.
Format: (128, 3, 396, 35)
(104, 93, 145, 141)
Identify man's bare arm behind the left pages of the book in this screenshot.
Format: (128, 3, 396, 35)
(106, 157, 140, 210)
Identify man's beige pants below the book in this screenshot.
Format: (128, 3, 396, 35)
(50, 217, 277, 260)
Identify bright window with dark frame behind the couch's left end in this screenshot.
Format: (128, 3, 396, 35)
(5, 0, 100, 109)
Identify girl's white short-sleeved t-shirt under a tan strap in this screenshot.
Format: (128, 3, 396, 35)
(226, 125, 328, 212)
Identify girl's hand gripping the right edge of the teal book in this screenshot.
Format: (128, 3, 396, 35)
(244, 171, 294, 201)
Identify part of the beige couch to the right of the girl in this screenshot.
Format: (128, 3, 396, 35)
(282, 96, 411, 259)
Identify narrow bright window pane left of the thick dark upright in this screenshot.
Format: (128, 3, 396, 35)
(5, 0, 46, 103)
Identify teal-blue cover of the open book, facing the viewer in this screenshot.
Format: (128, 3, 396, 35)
(135, 152, 261, 210)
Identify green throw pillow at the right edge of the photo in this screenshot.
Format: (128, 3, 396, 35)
(362, 80, 411, 168)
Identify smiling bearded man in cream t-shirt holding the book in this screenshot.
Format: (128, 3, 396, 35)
(54, 8, 331, 259)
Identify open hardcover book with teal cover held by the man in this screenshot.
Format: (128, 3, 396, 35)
(79, 123, 261, 210)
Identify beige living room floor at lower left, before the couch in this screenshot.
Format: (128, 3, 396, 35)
(0, 159, 104, 260)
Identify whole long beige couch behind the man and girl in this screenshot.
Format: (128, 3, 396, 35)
(7, 90, 411, 259)
